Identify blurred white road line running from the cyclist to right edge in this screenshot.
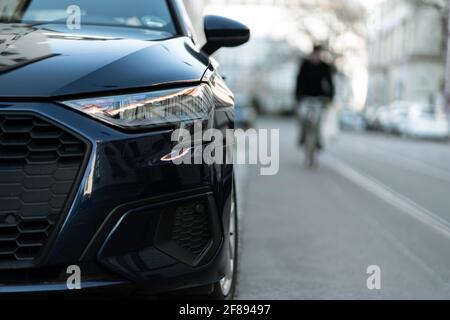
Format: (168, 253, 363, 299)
(322, 155, 450, 239)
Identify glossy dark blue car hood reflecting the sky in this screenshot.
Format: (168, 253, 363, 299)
(0, 24, 208, 98)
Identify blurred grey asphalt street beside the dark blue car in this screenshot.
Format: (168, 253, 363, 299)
(234, 120, 450, 299)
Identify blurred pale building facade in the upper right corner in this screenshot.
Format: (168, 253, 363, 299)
(367, 0, 448, 106)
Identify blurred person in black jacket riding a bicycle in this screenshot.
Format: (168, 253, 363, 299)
(295, 45, 334, 149)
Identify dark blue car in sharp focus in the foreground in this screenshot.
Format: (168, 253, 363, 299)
(0, 0, 249, 298)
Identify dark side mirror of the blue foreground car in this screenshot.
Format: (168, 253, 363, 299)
(202, 16, 250, 55)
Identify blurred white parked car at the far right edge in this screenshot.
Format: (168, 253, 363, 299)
(400, 105, 450, 140)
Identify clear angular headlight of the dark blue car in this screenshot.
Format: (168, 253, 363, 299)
(62, 84, 214, 129)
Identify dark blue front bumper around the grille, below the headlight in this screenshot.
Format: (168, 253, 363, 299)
(0, 102, 233, 293)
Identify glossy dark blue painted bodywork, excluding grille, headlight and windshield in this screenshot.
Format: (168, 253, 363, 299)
(0, 2, 234, 293)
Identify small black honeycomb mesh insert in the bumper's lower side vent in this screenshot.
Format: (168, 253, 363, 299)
(172, 204, 211, 255)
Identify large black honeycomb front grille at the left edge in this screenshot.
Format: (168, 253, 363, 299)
(0, 113, 87, 265)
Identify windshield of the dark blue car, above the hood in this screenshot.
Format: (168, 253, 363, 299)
(0, 0, 176, 35)
